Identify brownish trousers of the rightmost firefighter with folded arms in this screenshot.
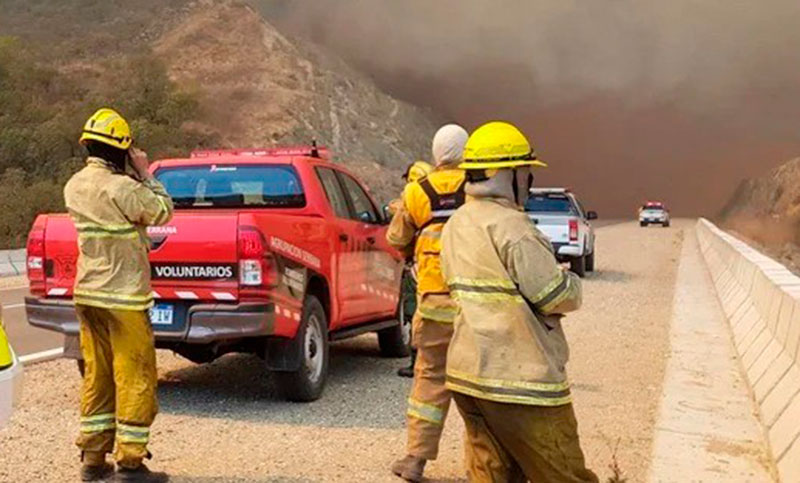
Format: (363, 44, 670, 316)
(453, 393, 598, 483)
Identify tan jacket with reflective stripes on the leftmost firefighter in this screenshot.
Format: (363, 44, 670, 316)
(64, 157, 173, 310)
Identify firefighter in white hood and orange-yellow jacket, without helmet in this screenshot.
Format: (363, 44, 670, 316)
(386, 124, 469, 481)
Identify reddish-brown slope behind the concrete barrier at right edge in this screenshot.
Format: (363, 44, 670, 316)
(719, 158, 800, 271)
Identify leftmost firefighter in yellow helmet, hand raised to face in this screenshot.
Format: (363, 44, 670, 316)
(64, 109, 173, 481)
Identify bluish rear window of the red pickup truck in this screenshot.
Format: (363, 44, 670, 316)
(155, 164, 306, 208)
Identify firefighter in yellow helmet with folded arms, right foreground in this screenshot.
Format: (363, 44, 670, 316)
(441, 122, 597, 482)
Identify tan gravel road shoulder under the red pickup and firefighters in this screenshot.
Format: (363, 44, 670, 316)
(0, 220, 691, 482)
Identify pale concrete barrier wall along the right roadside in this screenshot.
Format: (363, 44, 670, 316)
(697, 219, 800, 482)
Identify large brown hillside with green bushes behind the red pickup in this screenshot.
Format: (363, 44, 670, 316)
(0, 0, 438, 247)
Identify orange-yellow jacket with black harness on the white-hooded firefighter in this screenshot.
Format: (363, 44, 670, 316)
(386, 166, 466, 323)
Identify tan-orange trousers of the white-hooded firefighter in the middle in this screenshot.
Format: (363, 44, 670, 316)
(406, 310, 453, 460)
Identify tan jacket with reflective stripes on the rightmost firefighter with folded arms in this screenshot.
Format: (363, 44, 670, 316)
(442, 198, 581, 406)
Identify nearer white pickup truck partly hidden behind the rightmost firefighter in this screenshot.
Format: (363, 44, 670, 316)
(525, 188, 597, 277)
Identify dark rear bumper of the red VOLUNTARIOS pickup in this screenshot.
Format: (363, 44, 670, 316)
(25, 297, 286, 344)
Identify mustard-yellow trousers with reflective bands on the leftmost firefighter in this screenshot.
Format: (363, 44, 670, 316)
(75, 304, 158, 468)
